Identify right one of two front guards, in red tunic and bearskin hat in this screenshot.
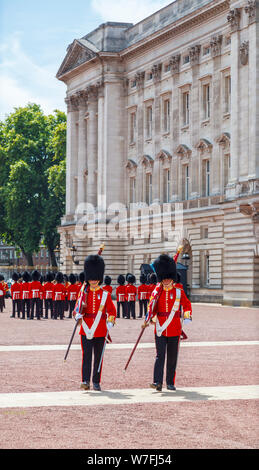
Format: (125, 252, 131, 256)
(142, 255, 192, 391)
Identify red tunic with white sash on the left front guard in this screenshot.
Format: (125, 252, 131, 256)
(79, 287, 116, 338)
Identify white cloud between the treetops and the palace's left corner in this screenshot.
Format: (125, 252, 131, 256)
(0, 33, 65, 119)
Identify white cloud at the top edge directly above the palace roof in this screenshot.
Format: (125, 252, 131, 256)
(91, 0, 172, 23)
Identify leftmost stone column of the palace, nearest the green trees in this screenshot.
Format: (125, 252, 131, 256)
(65, 96, 78, 215)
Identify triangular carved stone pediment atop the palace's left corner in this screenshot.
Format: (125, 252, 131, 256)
(57, 39, 99, 78)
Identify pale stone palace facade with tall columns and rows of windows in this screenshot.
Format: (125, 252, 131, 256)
(57, 0, 259, 305)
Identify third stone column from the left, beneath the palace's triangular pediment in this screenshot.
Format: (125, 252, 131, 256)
(86, 86, 98, 207)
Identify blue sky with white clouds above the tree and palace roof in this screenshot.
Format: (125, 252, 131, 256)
(0, 0, 171, 120)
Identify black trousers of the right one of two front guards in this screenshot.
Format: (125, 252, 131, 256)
(154, 335, 180, 385)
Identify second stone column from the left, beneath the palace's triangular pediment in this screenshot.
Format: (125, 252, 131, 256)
(77, 90, 87, 208)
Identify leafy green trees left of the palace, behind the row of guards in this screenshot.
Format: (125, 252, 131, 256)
(0, 103, 66, 265)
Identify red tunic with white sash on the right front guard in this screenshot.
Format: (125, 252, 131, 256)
(147, 284, 192, 336)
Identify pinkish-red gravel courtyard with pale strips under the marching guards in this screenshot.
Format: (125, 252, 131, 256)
(0, 300, 259, 450)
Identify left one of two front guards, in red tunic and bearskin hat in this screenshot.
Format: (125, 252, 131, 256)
(75, 255, 116, 391)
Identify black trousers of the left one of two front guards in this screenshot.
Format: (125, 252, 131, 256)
(81, 335, 105, 384)
